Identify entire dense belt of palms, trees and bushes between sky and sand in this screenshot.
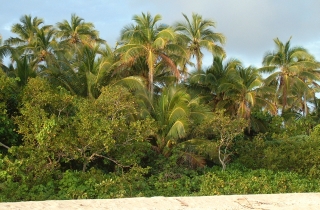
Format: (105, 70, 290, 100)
(0, 13, 320, 201)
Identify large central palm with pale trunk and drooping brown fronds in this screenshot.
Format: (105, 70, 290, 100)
(116, 13, 185, 95)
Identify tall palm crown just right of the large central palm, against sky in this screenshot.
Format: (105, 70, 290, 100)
(176, 13, 225, 71)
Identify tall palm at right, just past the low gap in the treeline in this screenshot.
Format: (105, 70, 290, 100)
(261, 38, 314, 111)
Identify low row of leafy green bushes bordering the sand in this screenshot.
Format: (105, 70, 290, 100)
(0, 164, 320, 202)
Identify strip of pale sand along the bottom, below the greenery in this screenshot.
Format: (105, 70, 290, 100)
(0, 193, 320, 210)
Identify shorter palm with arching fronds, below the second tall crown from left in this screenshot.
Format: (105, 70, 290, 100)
(41, 41, 117, 98)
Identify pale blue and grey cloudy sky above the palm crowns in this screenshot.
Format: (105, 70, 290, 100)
(0, 0, 320, 67)
